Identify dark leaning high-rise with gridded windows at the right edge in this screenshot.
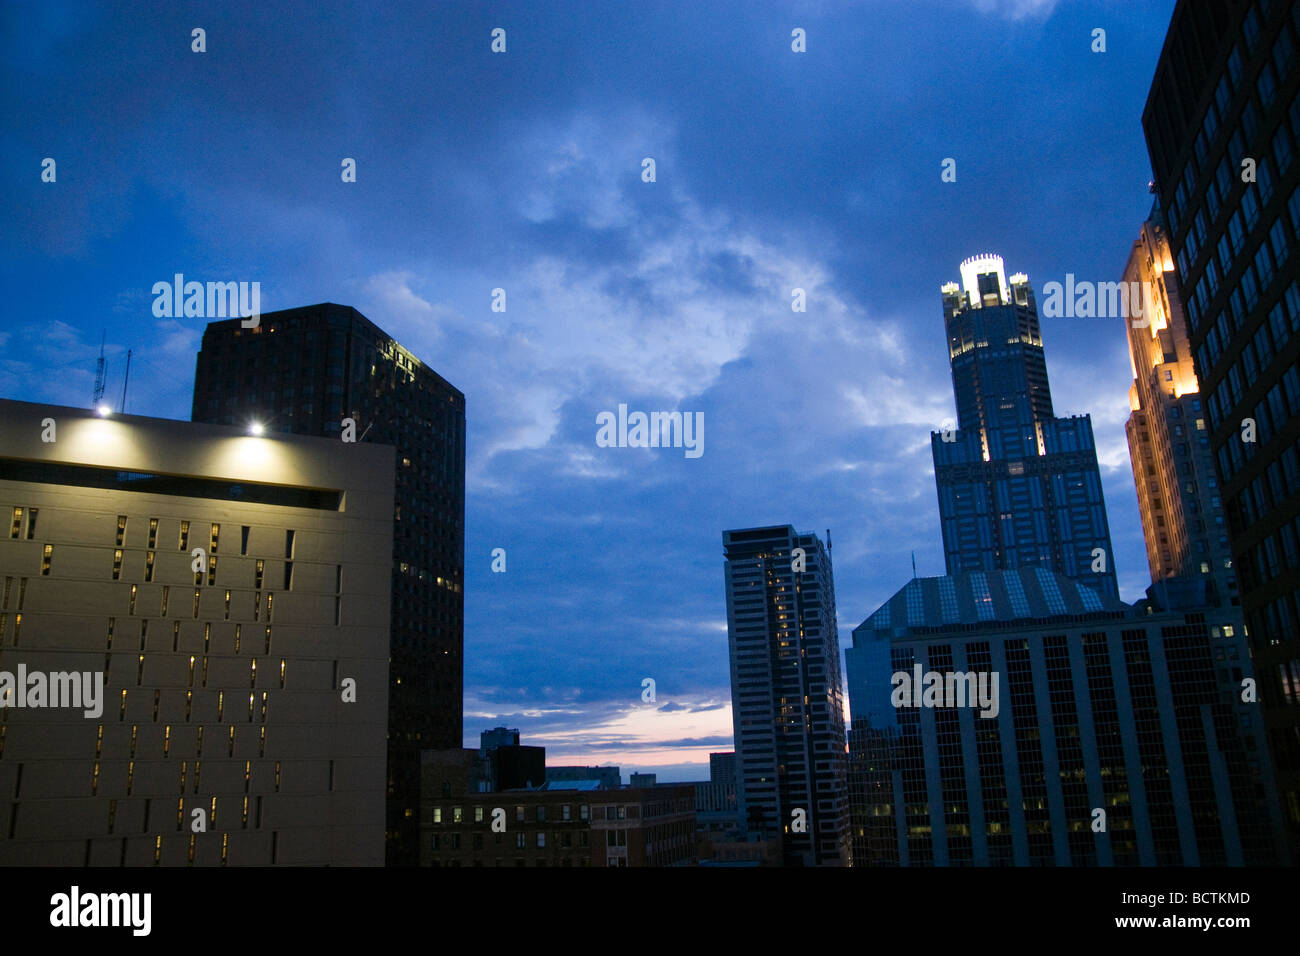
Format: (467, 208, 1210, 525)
(1143, 0, 1300, 855)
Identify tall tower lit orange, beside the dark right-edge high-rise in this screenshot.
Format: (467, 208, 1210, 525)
(1123, 209, 1240, 605)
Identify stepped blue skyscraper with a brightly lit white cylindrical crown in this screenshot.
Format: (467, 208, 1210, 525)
(931, 255, 1119, 597)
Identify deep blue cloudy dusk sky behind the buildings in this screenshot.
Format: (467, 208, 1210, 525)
(0, 0, 1174, 779)
